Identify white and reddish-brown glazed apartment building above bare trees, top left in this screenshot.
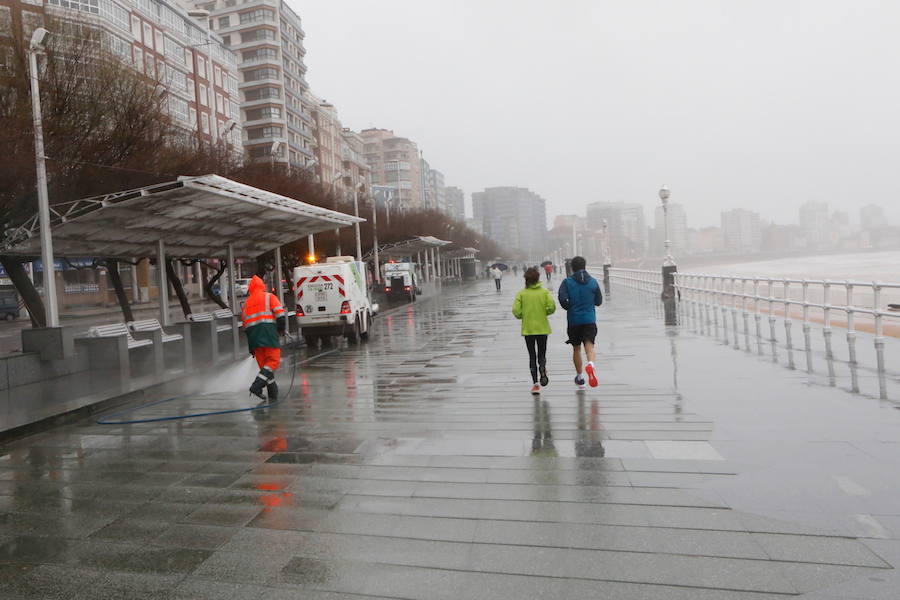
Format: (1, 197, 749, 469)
(0, 0, 242, 153)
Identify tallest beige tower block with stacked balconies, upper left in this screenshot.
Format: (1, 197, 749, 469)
(195, 0, 318, 168)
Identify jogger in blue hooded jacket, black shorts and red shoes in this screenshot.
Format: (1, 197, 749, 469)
(558, 256, 603, 390)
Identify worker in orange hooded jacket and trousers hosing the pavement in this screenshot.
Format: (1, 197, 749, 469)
(241, 275, 287, 403)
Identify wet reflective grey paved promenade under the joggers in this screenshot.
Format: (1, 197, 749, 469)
(0, 278, 900, 600)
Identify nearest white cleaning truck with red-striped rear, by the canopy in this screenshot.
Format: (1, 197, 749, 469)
(293, 256, 378, 347)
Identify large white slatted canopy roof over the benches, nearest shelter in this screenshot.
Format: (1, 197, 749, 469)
(0, 175, 365, 258)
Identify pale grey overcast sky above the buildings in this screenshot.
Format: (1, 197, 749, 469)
(288, 0, 900, 227)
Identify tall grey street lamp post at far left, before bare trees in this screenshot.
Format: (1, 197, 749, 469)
(28, 27, 59, 327)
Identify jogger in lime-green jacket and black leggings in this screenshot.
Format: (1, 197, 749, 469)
(513, 267, 556, 395)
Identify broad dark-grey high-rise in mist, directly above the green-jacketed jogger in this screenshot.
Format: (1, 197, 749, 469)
(472, 187, 547, 255)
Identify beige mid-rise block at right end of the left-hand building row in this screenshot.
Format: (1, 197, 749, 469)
(360, 129, 424, 210)
